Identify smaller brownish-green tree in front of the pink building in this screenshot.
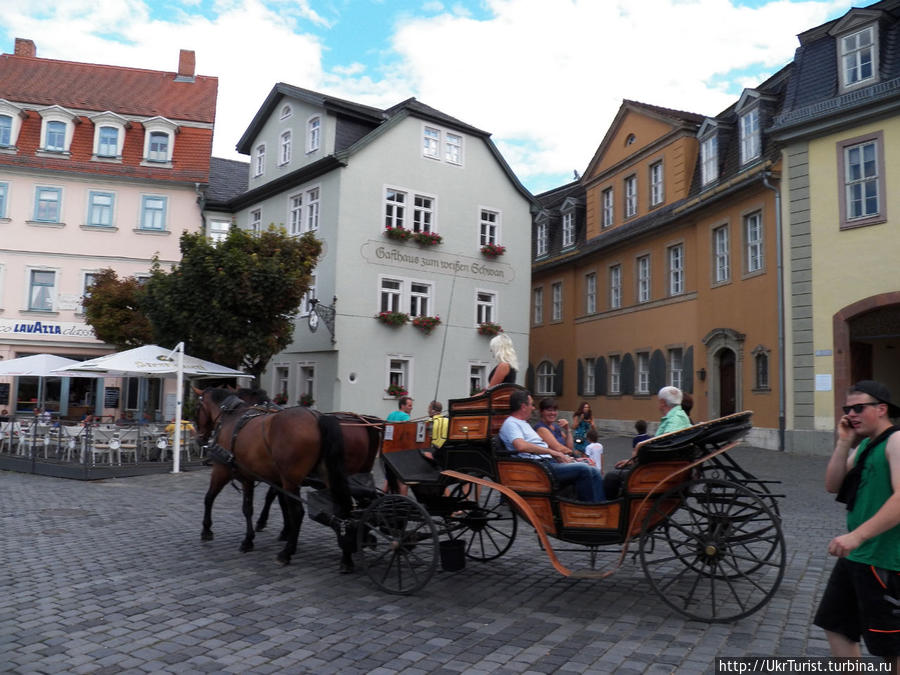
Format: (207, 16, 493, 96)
(82, 269, 153, 349)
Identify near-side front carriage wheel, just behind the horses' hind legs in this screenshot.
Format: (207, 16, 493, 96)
(357, 495, 438, 595)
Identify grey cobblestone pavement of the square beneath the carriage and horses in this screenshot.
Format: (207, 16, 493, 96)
(0, 438, 843, 673)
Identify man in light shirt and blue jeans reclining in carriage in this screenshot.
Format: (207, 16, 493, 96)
(499, 390, 606, 502)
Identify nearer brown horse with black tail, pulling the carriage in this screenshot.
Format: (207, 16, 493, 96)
(194, 389, 380, 569)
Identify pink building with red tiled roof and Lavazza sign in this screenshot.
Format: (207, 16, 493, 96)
(0, 38, 218, 416)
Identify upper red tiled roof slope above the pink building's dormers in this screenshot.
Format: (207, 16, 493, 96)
(0, 54, 219, 124)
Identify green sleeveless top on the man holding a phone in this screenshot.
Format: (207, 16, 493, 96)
(847, 432, 900, 571)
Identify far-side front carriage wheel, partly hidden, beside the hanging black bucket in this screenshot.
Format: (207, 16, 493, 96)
(445, 469, 518, 562)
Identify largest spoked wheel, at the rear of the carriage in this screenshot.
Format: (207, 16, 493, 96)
(640, 478, 785, 623)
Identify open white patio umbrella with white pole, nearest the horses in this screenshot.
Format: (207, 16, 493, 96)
(58, 342, 252, 473)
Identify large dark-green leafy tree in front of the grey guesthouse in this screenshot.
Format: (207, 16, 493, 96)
(81, 227, 322, 377)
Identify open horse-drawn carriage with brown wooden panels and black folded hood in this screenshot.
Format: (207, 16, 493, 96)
(195, 385, 785, 622)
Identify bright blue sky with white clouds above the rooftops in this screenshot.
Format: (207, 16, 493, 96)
(0, 0, 871, 194)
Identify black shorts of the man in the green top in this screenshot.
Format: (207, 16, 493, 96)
(813, 558, 900, 657)
